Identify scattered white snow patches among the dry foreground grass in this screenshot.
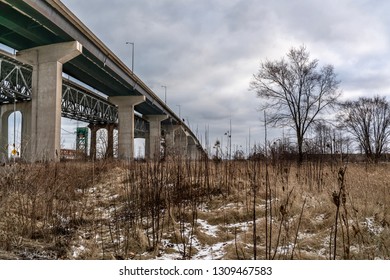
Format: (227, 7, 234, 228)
(70, 175, 384, 260)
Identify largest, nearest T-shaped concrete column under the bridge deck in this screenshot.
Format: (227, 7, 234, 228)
(16, 42, 82, 161)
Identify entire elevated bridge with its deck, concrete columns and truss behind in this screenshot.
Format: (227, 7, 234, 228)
(0, 0, 203, 162)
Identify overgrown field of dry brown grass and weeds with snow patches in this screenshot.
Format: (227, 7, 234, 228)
(0, 159, 390, 259)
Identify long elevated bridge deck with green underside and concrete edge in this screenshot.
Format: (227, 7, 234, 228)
(0, 0, 204, 149)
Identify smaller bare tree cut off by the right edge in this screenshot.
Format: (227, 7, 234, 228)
(340, 96, 390, 162)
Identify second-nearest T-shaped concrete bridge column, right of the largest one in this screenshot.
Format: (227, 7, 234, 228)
(109, 96, 145, 160)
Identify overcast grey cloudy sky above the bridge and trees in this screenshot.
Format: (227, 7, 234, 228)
(58, 0, 390, 156)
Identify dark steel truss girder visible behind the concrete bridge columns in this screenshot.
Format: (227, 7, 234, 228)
(0, 53, 149, 136)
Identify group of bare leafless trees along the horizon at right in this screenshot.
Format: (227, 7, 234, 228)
(249, 46, 390, 163)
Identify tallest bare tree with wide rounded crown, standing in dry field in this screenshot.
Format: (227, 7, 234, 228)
(250, 46, 340, 162)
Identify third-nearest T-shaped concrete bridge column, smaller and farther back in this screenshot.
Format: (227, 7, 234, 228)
(144, 115, 168, 159)
